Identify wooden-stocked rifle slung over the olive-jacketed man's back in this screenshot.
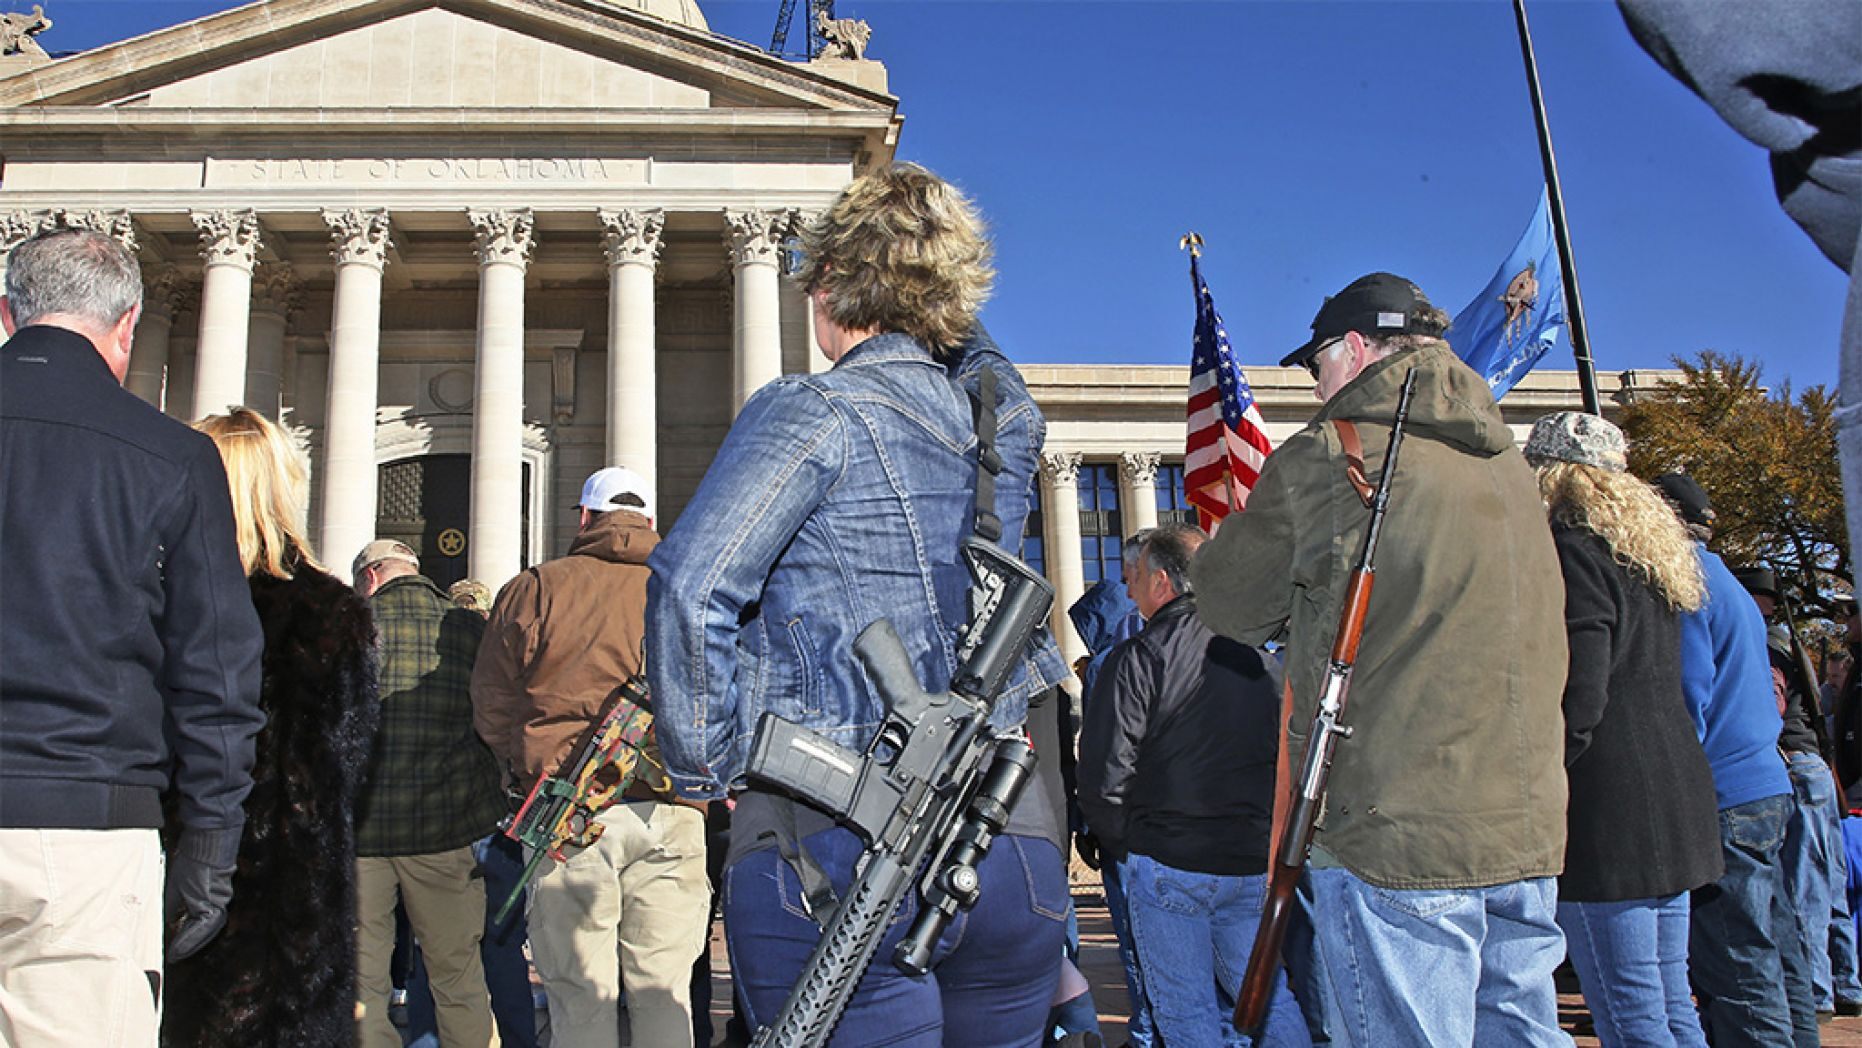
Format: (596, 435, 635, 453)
(1235, 370, 1415, 1037)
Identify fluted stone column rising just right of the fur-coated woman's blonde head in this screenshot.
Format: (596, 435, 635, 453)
(317, 208, 389, 581)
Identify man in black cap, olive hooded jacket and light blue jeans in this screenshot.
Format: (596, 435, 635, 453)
(1192, 274, 1570, 1048)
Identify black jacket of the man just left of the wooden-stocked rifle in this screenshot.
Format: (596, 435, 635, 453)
(1080, 596, 1281, 875)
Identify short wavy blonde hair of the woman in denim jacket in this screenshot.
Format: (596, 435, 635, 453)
(795, 164, 996, 356)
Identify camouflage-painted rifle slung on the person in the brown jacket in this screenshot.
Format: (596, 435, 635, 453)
(492, 674, 663, 923)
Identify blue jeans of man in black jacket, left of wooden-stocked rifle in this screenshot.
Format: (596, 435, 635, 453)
(1119, 854, 1313, 1048)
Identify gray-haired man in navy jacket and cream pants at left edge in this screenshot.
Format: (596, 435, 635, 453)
(0, 229, 264, 1046)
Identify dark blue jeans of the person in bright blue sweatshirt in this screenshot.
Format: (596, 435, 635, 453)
(1687, 795, 1815, 1048)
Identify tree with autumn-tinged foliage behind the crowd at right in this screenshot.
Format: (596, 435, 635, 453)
(1624, 350, 1851, 620)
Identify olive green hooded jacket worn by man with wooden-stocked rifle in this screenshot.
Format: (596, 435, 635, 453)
(1192, 344, 1566, 888)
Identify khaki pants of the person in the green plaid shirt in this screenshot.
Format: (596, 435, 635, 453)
(356, 847, 492, 1048)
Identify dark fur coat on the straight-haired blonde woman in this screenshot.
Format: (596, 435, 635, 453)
(162, 566, 382, 1048)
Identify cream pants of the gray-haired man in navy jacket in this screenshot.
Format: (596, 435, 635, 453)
(0, 830, 162, 1048)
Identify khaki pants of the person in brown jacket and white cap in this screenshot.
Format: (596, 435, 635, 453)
(529, 800, 711, 1048)
